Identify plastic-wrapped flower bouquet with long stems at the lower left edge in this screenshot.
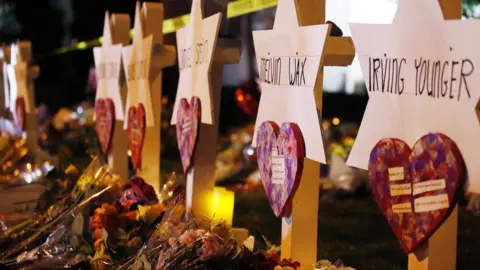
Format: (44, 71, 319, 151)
(0, 158, 120, 264)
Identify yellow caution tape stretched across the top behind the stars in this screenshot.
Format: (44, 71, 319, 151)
(54, 0, 278, 54)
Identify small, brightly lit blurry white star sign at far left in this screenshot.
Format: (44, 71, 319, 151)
(7, 44, 31, 113)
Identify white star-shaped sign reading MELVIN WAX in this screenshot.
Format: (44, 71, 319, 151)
(249, 0, 328, 163)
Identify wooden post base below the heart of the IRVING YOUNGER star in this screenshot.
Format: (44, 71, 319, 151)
(408, 205, 458, 270)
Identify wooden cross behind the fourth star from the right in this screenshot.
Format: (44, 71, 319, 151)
(139, 2, 176, 193)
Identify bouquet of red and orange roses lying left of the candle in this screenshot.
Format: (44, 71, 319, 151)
(89, 174, 184, 269)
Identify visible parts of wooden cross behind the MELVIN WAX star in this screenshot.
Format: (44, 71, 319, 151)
(281, 0, 355, 269)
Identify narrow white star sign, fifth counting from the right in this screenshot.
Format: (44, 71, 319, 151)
(93, 12, 124, 120)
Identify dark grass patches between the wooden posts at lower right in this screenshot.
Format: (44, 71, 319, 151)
(233, 190, 480, 270)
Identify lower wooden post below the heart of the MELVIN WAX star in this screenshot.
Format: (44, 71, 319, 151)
(281, 159, 320, 270)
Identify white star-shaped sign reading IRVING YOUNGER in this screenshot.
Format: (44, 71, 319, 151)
(348, 0, 480, 192)
